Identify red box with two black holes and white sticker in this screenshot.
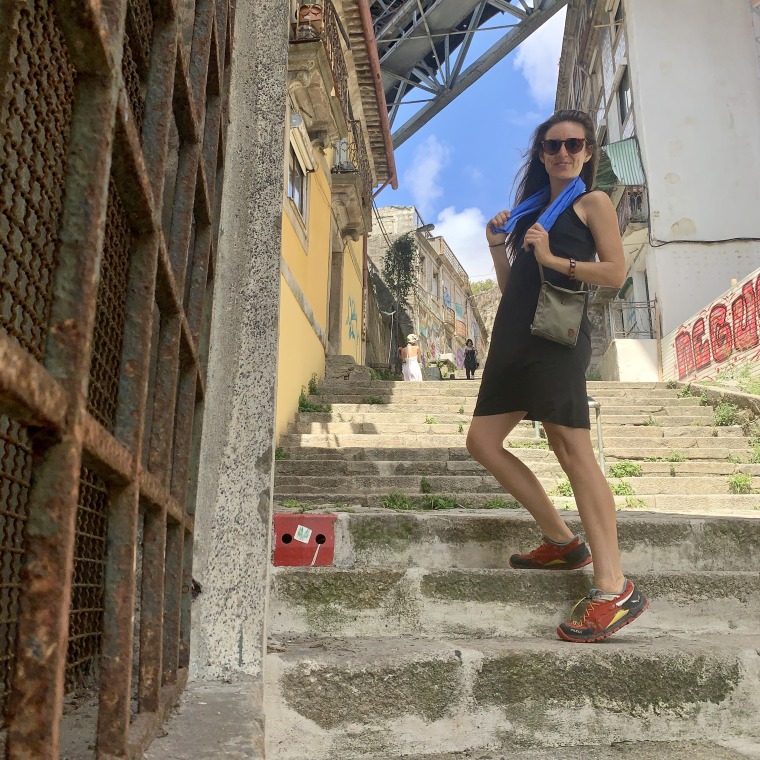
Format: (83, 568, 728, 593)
(274, 515, 338, 567)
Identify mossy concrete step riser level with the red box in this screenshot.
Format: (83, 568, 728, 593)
(276, 509, 760, 574)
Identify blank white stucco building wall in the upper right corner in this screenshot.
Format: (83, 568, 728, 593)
(625, 0, 760, 241)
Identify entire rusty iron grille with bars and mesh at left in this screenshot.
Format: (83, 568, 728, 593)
(0, 0, 234, 760)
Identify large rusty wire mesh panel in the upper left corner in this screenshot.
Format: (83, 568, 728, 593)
(0, 0, 76, 361)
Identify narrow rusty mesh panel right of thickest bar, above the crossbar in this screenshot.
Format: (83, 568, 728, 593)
(87, 180, 132, 431)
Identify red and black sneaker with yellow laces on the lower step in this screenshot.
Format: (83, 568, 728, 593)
(557, 579, 649, 644)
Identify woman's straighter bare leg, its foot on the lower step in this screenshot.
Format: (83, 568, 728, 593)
(544, 422, 625, 594)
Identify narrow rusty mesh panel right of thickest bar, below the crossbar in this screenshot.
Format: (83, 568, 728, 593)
(66, 467, 108, 689)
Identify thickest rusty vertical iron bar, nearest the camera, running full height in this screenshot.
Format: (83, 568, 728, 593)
(6, 2, 123, 760)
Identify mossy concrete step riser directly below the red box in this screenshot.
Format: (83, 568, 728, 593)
(269, 567, 760, 639)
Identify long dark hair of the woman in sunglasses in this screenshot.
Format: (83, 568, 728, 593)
(507, 109, 599, 261)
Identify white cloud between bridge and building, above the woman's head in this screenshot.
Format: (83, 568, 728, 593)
(514, 8, 565, 106)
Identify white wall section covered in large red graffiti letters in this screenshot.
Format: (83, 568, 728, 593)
(662, 270, 760, 380)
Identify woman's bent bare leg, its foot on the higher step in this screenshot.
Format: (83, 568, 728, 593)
(467, 412, 576, 543)
